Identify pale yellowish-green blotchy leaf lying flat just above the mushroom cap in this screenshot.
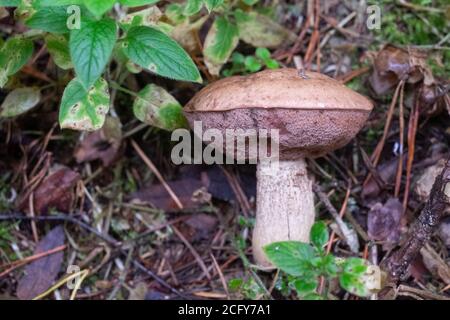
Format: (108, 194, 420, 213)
(235, 10, 296, 48)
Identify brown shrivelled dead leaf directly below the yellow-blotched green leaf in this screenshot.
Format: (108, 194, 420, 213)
(74, 117, 122, 167)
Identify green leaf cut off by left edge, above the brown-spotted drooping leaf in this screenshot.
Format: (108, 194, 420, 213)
(0, 37, 34, 88)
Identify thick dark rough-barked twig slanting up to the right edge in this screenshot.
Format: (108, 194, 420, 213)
(382, 158, 450, 282)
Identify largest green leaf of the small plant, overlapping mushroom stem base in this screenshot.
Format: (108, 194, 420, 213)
(264, 241, 314, 276)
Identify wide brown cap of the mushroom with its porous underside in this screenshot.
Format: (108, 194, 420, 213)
(184, 69, 372, 159)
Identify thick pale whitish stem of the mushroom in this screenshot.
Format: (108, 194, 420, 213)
(253, 158, 315, 267)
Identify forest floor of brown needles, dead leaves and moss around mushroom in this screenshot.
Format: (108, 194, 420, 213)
(0, 0, 450, 299)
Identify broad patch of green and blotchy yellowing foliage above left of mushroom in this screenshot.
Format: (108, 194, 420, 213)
(0, 0, 286, 131)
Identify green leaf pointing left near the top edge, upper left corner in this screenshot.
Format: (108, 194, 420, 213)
(25, 7, 69, 33)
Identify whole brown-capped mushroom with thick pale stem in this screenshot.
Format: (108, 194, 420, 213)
(184, 68, 372, 267)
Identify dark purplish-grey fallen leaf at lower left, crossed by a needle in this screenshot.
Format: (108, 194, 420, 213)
(17, 226, 65, 300)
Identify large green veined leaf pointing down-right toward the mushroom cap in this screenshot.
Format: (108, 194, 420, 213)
(123, 27, 202, 83)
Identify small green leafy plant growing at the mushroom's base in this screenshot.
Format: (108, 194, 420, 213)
(264, 222, 381, 300)
